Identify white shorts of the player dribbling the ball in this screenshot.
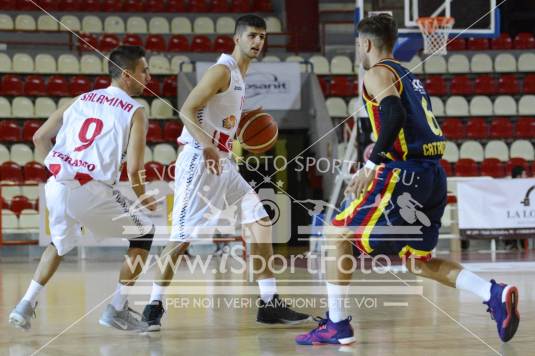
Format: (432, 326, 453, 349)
(171, 145, 269, 241)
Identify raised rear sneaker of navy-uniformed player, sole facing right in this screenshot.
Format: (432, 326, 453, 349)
(483, 279, 520, 342)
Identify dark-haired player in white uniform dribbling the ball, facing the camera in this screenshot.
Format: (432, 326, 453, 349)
(143, 15, 309, 331)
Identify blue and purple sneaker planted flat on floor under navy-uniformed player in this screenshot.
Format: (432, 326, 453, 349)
(295, 313, 357, 345)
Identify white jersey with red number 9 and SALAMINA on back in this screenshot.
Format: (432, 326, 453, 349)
(45, 86, 141, 184)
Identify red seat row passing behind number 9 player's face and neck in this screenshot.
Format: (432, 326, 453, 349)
(0, 74, 177, 97)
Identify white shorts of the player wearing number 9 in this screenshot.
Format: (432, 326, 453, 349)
(45, 177, 154, 256)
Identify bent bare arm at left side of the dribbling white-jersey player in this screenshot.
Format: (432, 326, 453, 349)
(180, 65, 230, 175)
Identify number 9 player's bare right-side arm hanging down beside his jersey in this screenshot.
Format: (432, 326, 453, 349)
(126, 108, 156, 210)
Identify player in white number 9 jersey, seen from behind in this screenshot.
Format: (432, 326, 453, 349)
(9, 46, 156, 330)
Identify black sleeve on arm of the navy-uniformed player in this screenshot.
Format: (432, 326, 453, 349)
(370, 95, 407, 164)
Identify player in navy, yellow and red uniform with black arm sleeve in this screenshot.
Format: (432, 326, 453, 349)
(296, 14, 520, 345)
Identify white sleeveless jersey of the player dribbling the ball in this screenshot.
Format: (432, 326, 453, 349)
(177, 54, 245, 152)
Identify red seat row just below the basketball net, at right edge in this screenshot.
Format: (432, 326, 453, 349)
(425, 74, 535, 96)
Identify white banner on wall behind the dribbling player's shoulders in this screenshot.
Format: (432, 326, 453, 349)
(195, 62, 301, 110)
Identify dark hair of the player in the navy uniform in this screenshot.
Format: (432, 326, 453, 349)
(357, 14, 398, 51)
